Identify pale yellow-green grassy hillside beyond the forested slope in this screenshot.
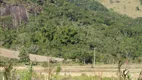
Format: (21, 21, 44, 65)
(98, 0, 142, 18)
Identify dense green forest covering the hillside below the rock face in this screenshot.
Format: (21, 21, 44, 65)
(0, 0, 142, 63)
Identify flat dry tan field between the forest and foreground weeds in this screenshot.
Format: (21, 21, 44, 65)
(0, 64, 142, 80)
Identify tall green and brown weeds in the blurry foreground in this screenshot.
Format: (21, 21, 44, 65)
(0, 60, 142, 80)
